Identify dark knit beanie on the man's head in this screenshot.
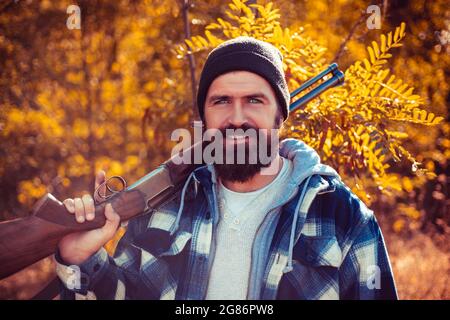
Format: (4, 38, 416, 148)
(197, 36, 290, 120)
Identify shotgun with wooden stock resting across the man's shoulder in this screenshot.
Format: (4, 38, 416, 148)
(0, 63, 344, 279)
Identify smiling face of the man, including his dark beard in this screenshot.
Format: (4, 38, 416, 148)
(204, 71, 282, 182)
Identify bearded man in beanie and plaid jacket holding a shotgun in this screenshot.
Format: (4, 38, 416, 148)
(55, 37, 397, 300)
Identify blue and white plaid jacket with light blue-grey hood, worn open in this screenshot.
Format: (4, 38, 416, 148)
(56, 139, 397, 300)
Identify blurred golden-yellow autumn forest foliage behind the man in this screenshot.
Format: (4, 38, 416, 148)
(0, 0, 450, 299)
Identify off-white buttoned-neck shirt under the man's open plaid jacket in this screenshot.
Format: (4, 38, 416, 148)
(206, 158, 293, 300)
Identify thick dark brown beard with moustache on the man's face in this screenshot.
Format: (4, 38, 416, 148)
(214, 125, 272, 183)
